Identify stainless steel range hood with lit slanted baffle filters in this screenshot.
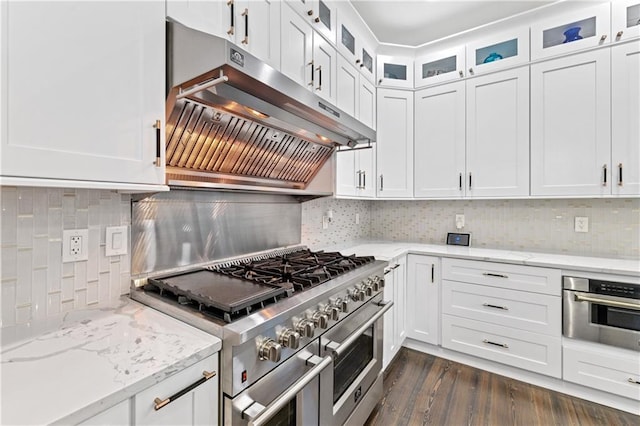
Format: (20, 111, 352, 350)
(166, 17, 375, 196)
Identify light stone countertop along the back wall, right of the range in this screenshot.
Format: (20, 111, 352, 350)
(314, 241, 640, 278)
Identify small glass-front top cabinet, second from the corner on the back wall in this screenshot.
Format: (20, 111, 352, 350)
(415, 46, 466, 89)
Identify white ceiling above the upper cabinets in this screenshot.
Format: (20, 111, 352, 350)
(351, 0, 554, 46)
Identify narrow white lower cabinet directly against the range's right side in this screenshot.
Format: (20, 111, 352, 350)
(382, 256, 407, 370)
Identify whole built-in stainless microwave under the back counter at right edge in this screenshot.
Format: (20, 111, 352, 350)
(563, 276, 640, 351)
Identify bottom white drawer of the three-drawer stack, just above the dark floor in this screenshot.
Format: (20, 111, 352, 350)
(442, 315, 562, 378)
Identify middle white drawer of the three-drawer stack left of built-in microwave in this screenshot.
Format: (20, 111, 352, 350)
(442, 281, 562, 337)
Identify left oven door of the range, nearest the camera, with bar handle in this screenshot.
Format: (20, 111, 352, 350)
(223, 343, 333, 426)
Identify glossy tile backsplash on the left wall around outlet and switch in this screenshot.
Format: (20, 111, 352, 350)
(0, 187, 131, 327)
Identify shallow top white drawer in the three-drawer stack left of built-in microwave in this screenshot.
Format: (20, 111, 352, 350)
(442, 258, 562, 296)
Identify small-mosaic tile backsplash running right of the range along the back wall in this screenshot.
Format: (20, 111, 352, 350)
(302, 199, 640, 259)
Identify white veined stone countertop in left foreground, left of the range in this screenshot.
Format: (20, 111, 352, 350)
(0, 298, 222, 425)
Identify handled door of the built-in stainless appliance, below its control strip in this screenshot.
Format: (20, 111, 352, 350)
(562, 290, 640, 351)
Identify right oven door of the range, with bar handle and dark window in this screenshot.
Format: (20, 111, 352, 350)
(320, 294, 393, 425)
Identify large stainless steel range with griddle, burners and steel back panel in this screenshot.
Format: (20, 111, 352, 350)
(131, 193, 392, 426)
